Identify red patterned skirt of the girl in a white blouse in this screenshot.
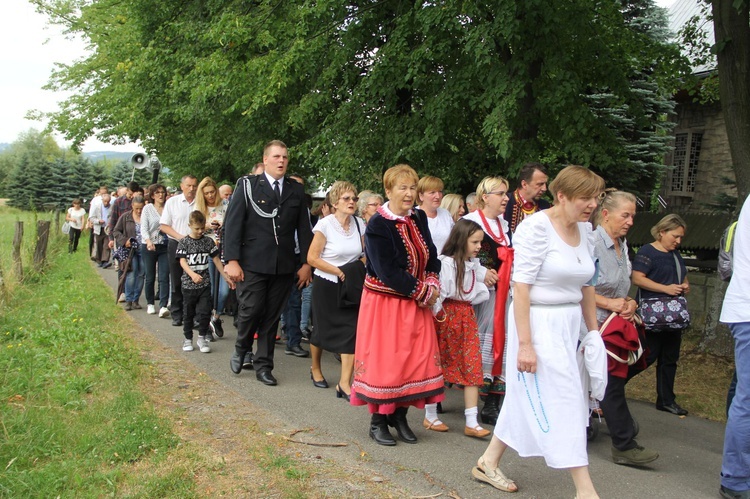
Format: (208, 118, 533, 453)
(435, 300, 483, 386)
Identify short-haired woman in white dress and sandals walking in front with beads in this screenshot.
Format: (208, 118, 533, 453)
(472, 166, 604, 499)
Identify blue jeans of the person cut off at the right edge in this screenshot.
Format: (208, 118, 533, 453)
(721, 322, 750, 491)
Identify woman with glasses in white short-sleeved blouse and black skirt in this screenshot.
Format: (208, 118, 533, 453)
(307, 181, 365, 401)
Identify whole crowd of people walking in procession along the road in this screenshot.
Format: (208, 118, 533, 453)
(66, 141, 748, 498)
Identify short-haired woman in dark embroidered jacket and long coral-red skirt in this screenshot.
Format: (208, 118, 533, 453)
(351, 165, 444, 445)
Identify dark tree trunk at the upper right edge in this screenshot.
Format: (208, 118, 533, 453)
(711, 0, 750, 207)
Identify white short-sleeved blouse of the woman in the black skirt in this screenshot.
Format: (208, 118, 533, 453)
(313, 215, 365, 282)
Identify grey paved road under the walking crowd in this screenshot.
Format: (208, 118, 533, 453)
(100, 270, 724, 499)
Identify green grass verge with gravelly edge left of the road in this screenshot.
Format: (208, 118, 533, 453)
(0, 220, 408, 498)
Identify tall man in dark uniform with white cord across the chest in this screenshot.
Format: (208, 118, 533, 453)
(224, 140, 312, 386)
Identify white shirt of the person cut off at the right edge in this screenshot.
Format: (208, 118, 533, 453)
(719, 196, 750, 324)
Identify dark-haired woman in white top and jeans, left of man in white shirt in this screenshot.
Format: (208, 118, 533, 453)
(141, 184, 169, 318)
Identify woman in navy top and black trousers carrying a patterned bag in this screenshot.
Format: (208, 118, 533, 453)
(633, 214, 690, 416)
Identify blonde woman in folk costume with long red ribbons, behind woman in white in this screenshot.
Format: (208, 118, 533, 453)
(464, 177, 513, 425)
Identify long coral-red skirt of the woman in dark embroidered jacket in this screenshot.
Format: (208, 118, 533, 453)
(350, 288, 444, 414)
